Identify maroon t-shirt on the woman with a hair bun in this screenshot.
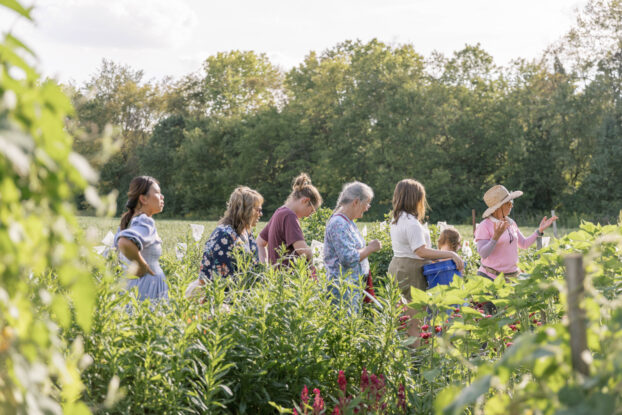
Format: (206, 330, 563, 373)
(259, 206, 305, 265)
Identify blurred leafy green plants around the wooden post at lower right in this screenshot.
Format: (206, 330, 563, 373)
(428, 223, 622, 414)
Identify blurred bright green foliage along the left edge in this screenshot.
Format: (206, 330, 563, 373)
(0, 0, 105, 414)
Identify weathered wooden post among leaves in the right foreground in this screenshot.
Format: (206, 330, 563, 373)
(564, 254, 590, 376)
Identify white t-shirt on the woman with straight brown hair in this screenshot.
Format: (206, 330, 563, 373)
(391, 212, 432, 259)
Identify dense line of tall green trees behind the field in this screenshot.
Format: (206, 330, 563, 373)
(66, 0, 622, 226)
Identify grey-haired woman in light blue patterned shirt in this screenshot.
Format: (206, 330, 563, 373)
(324, 182, 382, 311)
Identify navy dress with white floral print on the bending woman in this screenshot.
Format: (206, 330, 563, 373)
(199, 225, 259, 281)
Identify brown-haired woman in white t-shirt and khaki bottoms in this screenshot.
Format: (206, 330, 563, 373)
(389, 179, 464, 342)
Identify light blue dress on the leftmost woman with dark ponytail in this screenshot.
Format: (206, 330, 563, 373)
(114, 213, 168, 302)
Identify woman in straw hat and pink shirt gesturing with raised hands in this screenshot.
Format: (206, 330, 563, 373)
(475, 185, 557, 280)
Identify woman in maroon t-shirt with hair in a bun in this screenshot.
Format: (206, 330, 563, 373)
(257, 173, 322, 265)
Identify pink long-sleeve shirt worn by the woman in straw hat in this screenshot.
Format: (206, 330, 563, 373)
(475, 216, 538, 279)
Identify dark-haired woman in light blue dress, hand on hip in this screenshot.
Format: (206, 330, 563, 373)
(114, 176, 168, 301)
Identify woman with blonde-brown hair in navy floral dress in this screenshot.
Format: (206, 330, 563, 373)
(199, 186, 263, 283)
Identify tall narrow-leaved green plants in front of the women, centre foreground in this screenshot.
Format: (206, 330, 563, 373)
(71, 236, 411, 414)
